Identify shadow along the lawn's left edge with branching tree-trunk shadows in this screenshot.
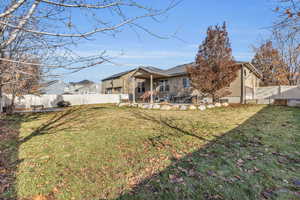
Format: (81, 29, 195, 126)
(0, 107, 82, 200)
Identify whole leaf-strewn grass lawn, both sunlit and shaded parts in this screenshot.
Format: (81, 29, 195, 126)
(0, 105, 300, 200)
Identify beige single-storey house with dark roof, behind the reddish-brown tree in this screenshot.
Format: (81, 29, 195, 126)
(102, 62, 262, 103)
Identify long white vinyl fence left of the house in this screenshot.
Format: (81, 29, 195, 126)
(3, 94, 129, 109)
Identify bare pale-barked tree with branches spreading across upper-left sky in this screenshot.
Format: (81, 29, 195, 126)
(0, 0, 180, 112)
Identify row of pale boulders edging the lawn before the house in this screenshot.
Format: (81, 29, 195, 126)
(117, 103, 229, 111)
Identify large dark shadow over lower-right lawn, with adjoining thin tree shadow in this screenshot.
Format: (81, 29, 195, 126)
(117, 106, 300, 200)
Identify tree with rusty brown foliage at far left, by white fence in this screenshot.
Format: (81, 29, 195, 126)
(0, 23, 50, 111)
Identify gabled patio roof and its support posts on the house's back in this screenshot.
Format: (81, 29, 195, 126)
(132, 67, 169, 104)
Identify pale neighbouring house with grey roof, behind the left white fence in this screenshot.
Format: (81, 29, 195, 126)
(64, 80, 101, 94)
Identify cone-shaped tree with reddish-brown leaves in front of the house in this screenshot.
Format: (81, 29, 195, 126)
(187, 23, 238, 102)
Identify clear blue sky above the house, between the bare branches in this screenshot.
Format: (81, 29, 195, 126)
(63, 0, 276, 82)
